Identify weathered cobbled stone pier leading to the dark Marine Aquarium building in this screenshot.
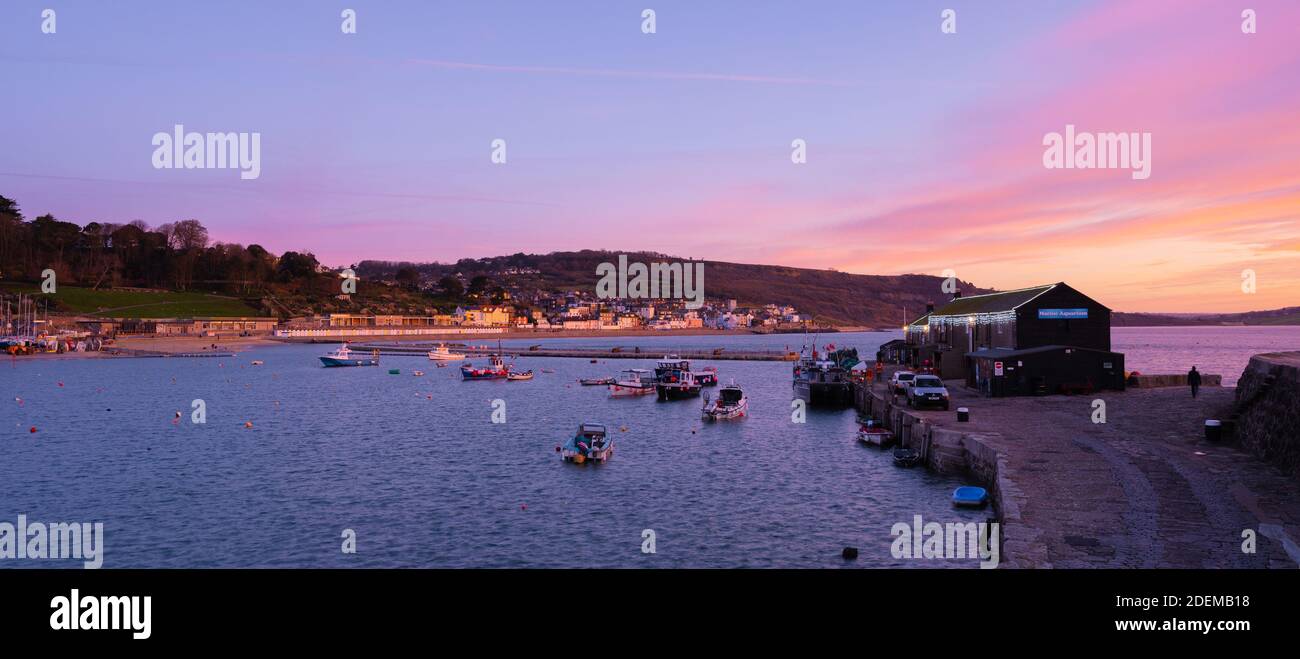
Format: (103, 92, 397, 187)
(857, 369, 1300, 568)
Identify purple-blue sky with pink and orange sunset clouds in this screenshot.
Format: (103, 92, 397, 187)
(0, 0, 1300, 312)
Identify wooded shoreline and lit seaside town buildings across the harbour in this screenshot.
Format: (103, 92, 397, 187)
(0, 213, 815, 355)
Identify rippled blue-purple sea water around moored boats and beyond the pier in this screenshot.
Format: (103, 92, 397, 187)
(0, 328, 1300, 567)
